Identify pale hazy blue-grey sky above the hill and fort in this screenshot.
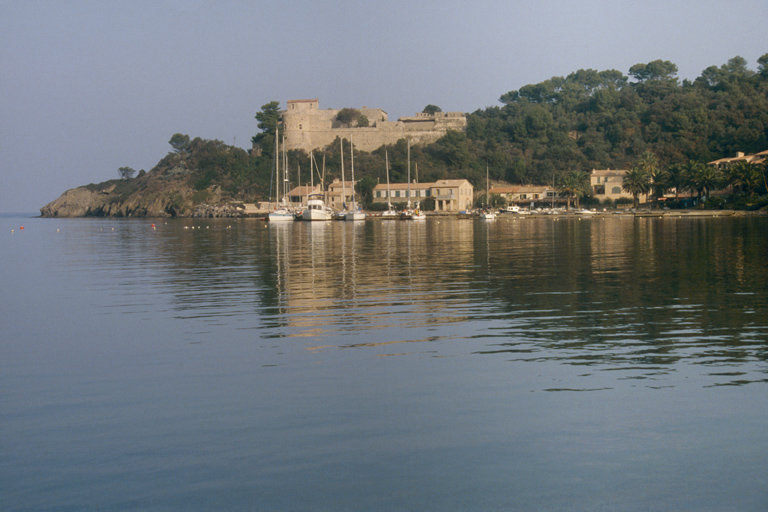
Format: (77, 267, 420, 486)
(0, 0, 768, 213)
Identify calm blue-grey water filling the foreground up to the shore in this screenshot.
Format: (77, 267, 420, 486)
(0, 212, 768, 512)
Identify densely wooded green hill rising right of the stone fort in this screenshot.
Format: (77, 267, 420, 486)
(467, 54, 768, 183)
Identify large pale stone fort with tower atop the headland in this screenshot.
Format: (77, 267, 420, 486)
(281, 99, 467, 152)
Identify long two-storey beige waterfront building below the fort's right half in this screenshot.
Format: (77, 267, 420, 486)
(373, 179, 474, 212)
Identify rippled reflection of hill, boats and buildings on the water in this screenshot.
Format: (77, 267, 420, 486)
(57, 218, 768, 389)
